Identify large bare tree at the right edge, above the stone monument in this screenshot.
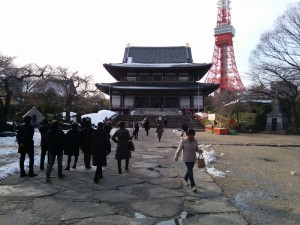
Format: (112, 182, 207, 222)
(249, 3, 300, 132)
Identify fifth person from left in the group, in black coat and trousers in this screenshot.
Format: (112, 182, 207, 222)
(80, 120, 95, 169)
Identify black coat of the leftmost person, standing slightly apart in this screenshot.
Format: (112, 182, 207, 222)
(16, 124, 34, 153)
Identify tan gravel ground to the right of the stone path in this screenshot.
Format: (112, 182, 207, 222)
(198, 132, 300, 225)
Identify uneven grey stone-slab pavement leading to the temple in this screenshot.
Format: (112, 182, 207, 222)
(0, 129, 247, 225)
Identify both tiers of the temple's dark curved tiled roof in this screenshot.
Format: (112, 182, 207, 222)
(96, 46, 219, 95)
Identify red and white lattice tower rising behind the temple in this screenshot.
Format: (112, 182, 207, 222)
(204, 0, 245, 92)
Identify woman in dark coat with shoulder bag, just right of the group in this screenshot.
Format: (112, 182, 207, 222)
(111, 121, 133, 174)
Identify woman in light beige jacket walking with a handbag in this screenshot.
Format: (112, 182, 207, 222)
(174, 129, 202, 192)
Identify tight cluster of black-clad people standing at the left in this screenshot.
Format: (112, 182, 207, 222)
(16, 116, 112, 183)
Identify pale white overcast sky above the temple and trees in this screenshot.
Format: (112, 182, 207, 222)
(0, 0, 298, 87)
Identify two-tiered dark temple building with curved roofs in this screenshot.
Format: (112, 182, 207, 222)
(96, 45, 219, 114)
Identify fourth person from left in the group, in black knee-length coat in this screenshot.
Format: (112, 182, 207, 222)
(64, 123, 80, 170)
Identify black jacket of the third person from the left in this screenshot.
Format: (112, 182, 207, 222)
(47, 127, 66, 154)
